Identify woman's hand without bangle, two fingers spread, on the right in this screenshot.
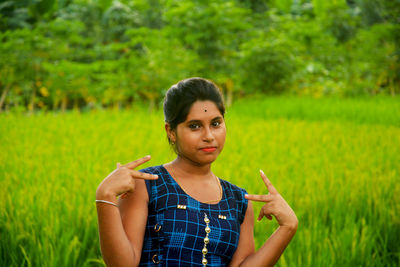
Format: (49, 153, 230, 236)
(245, 170, 298, 230)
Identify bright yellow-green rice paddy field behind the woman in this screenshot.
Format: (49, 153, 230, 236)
(0, 96, 400, 266)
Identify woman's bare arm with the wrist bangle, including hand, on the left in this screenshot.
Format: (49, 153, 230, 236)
(96, 157, 156, 266)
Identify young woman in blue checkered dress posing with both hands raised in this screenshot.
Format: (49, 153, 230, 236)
(96, 78, 298, 267)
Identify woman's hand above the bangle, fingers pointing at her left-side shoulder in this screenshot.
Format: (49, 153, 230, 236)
(96, 155, 158, 202)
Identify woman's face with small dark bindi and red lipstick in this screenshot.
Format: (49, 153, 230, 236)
(168, 100, 226, 165)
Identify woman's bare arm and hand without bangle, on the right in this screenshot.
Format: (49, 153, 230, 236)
(231, 172, 298, 267)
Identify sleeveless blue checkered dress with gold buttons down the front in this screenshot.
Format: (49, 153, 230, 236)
(139, 165, 247, 266)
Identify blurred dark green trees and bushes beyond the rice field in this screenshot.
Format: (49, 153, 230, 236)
(0, 0, 400, 112)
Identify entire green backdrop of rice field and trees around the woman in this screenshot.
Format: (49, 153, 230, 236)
(0, 0, 400, 267)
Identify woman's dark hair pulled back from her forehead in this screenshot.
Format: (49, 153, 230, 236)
(164, 77, 225, 136)
